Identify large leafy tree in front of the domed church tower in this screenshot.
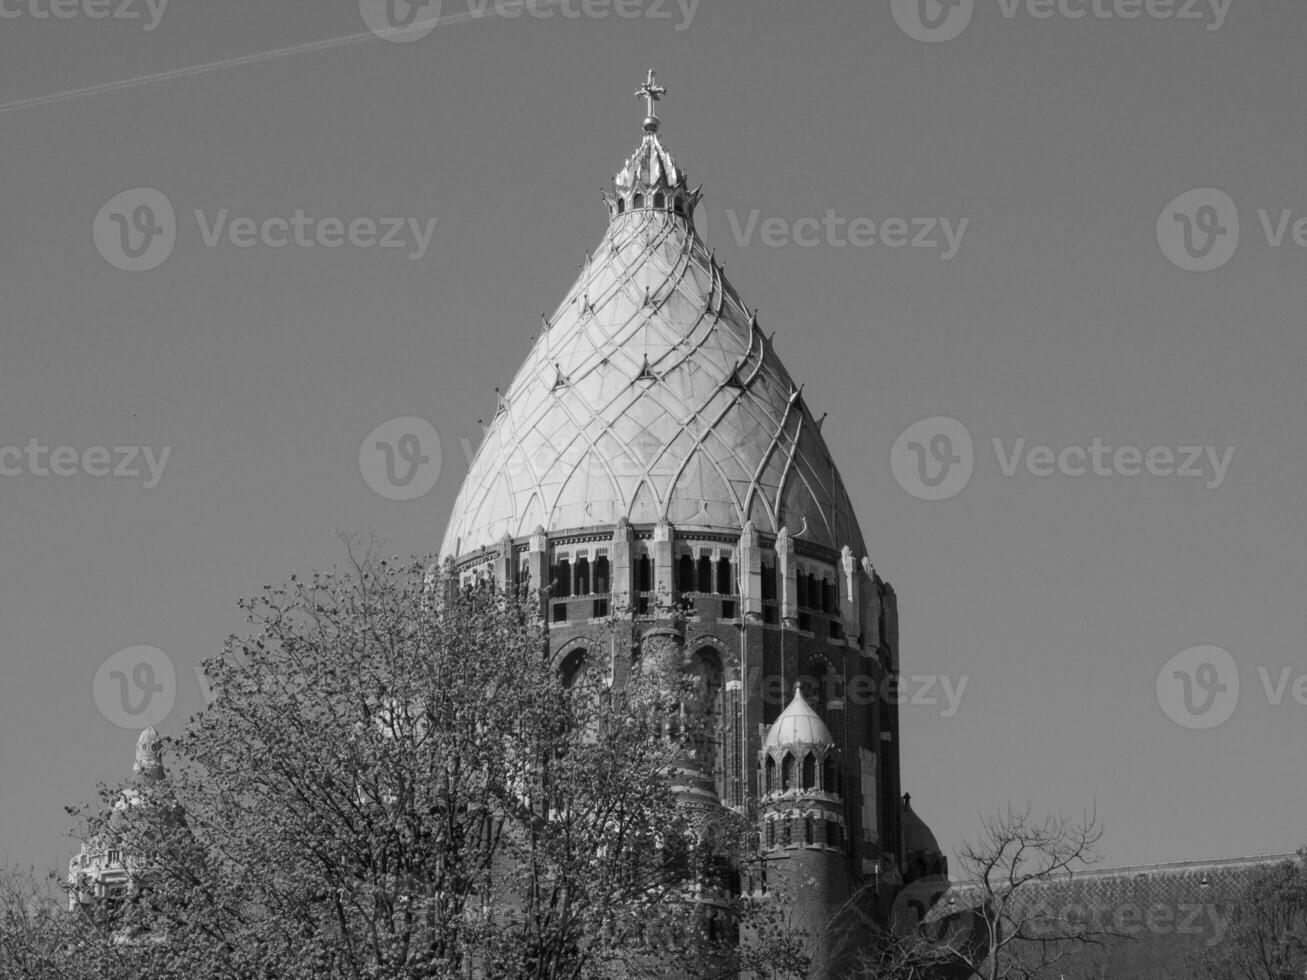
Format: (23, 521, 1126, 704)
(35, 557, 786, 980)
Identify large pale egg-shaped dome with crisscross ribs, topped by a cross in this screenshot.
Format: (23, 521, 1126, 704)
(440, 73, 864, 557)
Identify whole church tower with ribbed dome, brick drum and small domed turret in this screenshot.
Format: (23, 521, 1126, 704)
(440, 72, 938, 972)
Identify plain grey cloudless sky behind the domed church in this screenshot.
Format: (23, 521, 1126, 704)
(0, 0, 1307, 883)
